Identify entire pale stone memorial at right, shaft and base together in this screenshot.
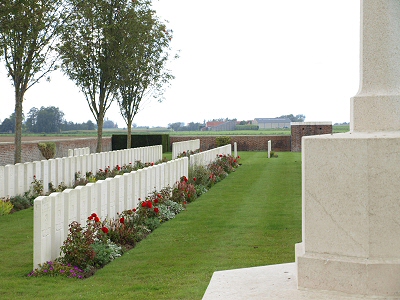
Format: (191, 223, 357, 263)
(296, 0, 400, 297)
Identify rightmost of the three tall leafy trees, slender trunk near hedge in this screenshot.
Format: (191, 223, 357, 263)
(117, 0, 174, 148)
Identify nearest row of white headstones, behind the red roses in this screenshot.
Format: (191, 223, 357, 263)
(34, 157, 189, 268)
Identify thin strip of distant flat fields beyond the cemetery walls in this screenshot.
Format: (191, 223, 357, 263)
(0, 125, 350, 143)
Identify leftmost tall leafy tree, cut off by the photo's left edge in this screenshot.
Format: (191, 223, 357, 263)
(0, 0, 63, 163)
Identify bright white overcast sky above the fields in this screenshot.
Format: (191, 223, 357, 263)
(0, 0, 360, 128)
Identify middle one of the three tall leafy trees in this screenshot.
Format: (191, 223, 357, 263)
(58, 0, 126, 152)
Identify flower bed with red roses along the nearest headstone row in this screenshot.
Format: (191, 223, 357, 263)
(29, 155, 240, 279)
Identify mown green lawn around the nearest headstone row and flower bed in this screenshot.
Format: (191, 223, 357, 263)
(0, 152, 301, 300)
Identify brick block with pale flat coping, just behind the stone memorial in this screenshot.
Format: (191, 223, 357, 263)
(291, 122, 332, 152)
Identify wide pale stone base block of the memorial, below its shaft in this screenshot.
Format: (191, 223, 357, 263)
(296, 132, 400, 296)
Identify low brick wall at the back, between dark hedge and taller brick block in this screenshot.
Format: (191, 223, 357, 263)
(170, 135, 291, 152)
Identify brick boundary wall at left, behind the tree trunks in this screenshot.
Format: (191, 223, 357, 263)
(0, 137, 111, 166)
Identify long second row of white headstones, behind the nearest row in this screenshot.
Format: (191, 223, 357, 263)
(0, 145, 162, 198)
